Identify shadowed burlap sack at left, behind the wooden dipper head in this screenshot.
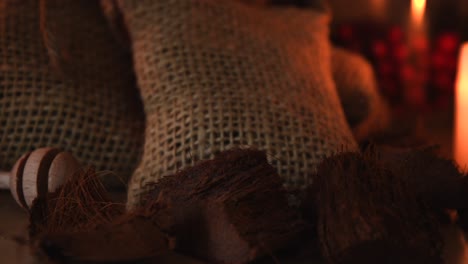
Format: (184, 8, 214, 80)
(0, 0, 144, 186)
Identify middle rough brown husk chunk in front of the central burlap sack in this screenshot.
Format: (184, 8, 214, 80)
(143, 149, 306, 263)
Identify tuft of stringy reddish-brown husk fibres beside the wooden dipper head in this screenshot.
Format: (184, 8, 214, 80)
(29, 169, 124, 237)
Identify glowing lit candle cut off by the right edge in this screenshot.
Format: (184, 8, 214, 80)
(454, 43, 468, 170)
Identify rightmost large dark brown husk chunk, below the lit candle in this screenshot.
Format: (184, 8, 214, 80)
(316, 153, 442, 263)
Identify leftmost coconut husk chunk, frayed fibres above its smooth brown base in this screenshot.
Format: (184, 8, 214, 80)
(29, 169, 169, 263)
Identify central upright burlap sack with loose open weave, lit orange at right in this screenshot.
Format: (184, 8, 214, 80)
(118, 0, 357, 207)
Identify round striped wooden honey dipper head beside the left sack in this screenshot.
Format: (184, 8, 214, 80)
(10, 148, 80, 209)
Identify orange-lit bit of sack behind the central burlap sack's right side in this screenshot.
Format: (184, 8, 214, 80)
(331, 47, 391, 141)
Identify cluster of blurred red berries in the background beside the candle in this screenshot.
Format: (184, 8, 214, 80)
(332, 24, 460, 112)
